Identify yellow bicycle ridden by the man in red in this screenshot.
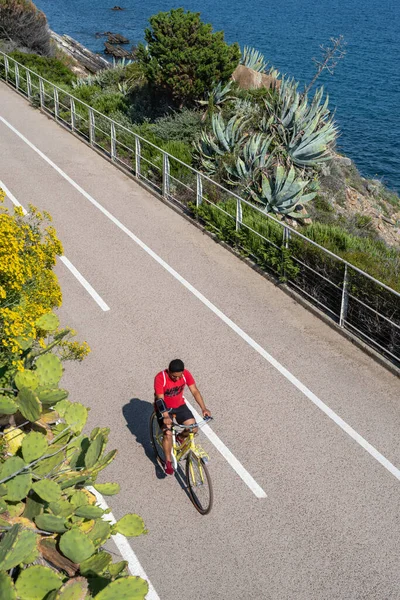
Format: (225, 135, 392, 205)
(150, 412, 214, 515)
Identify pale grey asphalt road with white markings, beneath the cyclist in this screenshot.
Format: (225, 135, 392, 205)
(0, 84, 400, 600)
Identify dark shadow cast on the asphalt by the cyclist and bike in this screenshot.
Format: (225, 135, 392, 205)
(122, 398, 190, 497)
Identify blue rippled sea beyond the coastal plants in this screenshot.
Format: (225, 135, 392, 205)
(35, 0, 400, 192)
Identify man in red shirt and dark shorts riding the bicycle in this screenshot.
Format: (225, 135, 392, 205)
(154, 358, 211, 475)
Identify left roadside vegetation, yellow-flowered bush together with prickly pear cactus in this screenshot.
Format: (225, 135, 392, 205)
(0, 190, 148, 600)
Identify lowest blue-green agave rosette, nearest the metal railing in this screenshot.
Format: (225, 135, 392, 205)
(253, 166, 316, 218)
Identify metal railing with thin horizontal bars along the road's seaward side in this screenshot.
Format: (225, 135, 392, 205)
(0, 51, 400, 366)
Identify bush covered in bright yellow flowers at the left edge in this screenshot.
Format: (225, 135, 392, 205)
(0, 189, 89, 381)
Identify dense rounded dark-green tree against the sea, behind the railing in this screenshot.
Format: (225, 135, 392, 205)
(137, 8, 240, 108)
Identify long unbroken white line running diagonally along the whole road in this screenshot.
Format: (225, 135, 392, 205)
(0, 117, 400, 488)
